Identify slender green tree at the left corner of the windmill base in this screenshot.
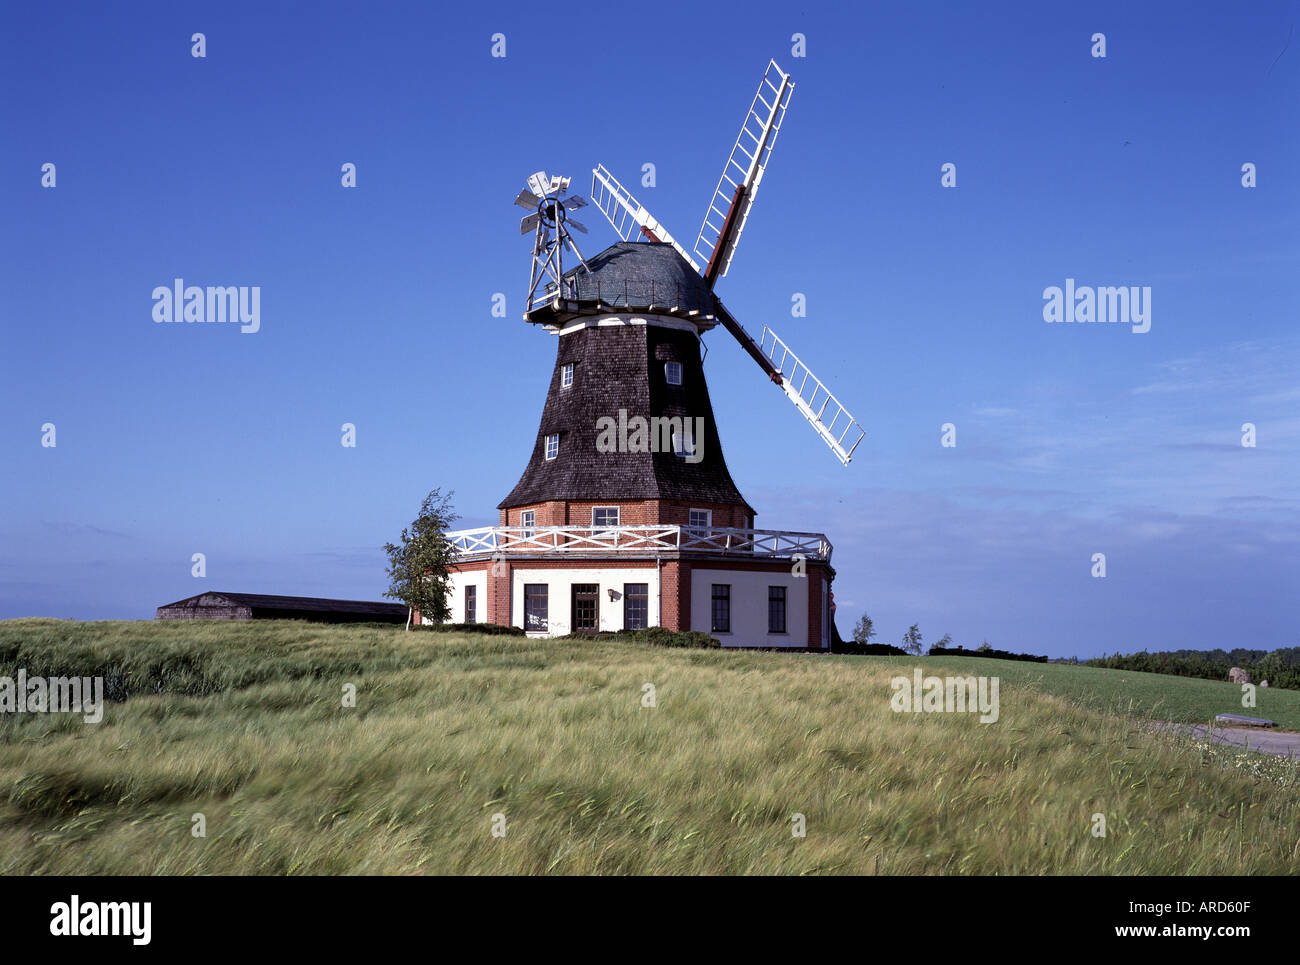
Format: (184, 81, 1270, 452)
(384, 489, 460, 629)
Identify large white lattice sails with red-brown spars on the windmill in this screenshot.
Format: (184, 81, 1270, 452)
(590, 60, 866, 466)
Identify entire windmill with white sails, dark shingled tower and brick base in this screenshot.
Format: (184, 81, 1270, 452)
(447, 64, 847, 652)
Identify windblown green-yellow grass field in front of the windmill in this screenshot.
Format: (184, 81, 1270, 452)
(0, 620, 1300, 874)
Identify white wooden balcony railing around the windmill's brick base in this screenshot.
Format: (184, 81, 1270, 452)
(447, 525, 833, 562)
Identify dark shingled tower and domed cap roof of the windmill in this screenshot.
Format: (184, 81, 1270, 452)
(497, 243, 753, 512)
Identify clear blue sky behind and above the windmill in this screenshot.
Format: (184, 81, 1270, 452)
(0, 0, 1300, 655)
